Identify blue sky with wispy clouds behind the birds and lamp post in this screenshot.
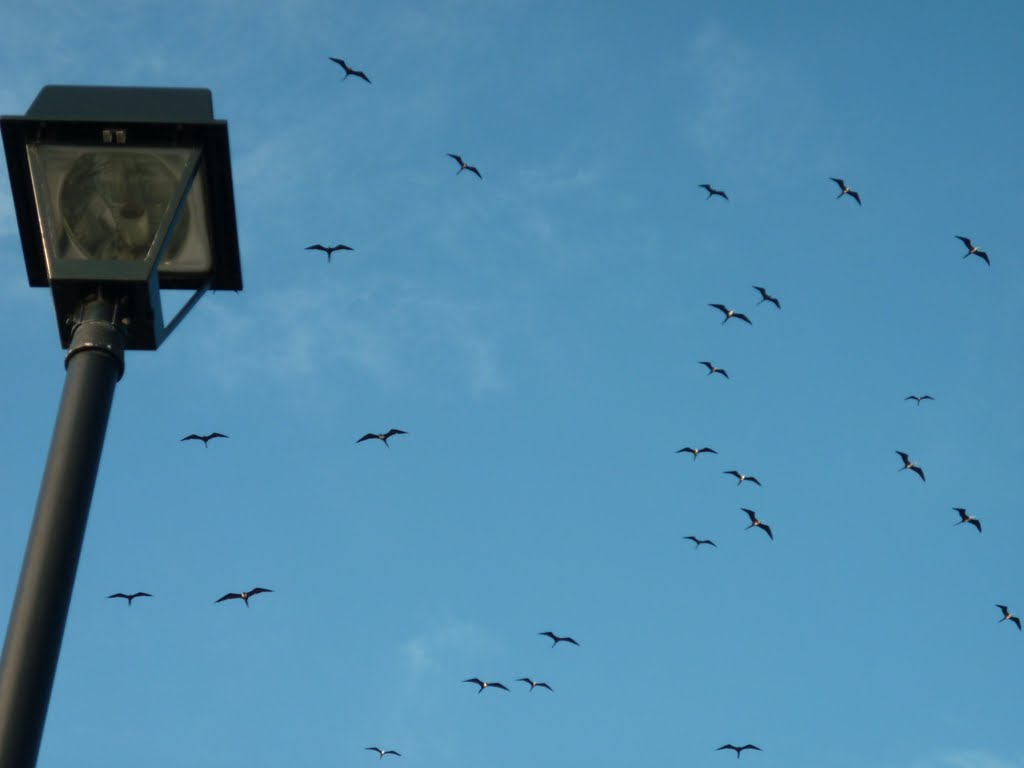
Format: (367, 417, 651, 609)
(0, 0, 1024, 768)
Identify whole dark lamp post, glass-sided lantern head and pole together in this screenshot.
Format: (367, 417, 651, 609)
(0, 86, 242, 768)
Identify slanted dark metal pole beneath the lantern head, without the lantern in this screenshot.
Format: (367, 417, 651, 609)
(0, 298, 124, 768)
